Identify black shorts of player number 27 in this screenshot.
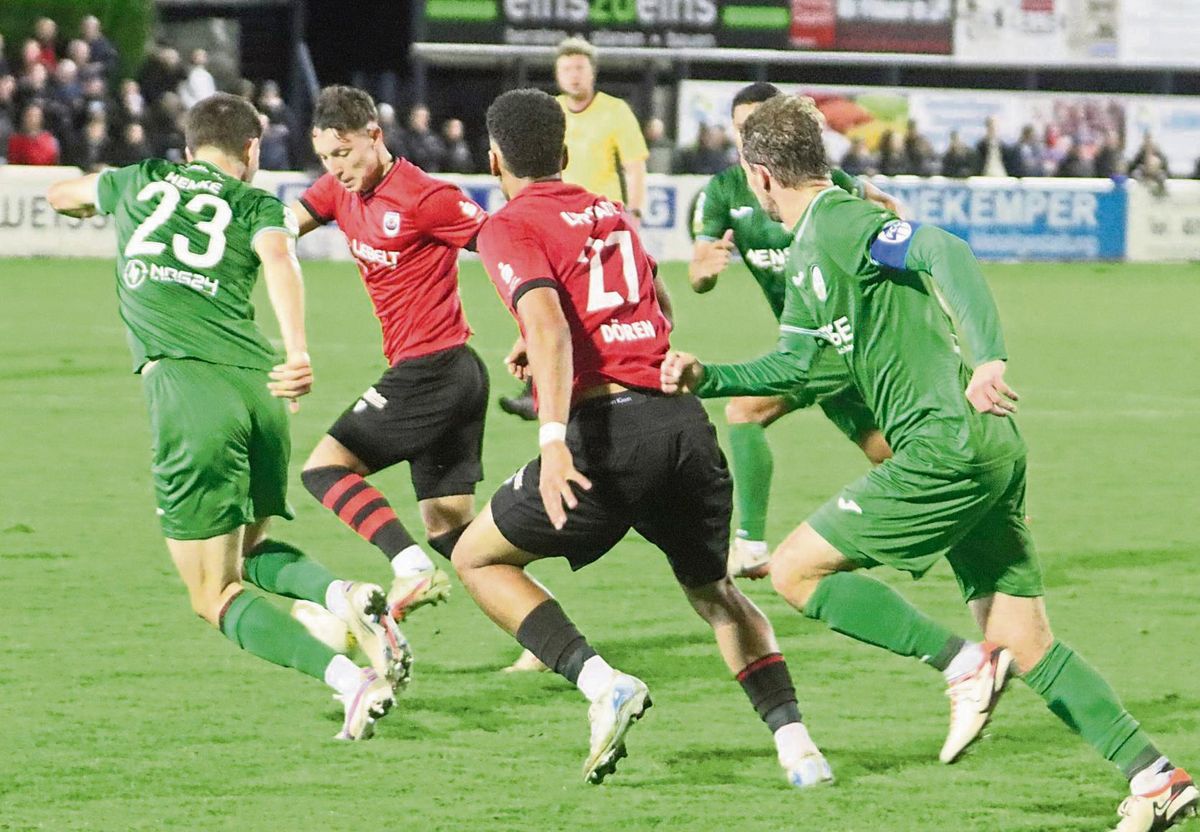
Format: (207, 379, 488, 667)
(492, 393, 733, 587)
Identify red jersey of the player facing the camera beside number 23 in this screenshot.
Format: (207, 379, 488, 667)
(300, 158, 487, 364)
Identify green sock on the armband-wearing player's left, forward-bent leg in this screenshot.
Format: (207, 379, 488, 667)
(804, 571, 965, 670)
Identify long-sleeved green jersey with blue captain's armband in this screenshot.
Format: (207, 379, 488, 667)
(697, 187, 1025, 469)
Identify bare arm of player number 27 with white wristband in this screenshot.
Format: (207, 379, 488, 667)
(516, 286, 592, 528)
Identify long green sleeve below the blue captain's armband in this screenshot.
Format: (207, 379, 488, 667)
(905, 226, 1008, 365)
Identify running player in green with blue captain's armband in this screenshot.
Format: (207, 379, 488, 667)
(662, 96, 1200, 832)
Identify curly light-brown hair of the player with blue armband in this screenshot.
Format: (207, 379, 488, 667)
(742, 95, 829, 187)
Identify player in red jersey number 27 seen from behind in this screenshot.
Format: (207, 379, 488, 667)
(454, 90, 832, 786)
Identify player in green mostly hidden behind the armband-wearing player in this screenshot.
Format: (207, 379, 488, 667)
(688, 82, 899, 579)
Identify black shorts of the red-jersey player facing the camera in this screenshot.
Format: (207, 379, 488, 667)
(329, 346, 488, 499)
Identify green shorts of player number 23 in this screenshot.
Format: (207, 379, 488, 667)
(142, 358, 293, 540)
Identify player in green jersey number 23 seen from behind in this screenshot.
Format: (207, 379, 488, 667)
(48, 94, 412, 740)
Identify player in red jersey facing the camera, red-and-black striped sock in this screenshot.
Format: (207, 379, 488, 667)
(292, 86, 488, 617)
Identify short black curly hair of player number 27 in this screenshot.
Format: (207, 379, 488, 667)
(487, 89, 566, 179)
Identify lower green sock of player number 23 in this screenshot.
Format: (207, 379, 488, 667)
(221, 592, 337, 680)
